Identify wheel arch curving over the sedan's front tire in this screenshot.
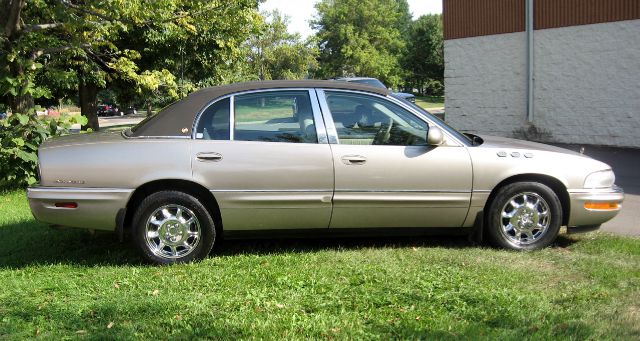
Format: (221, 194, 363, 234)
(484, 173, 571, 226)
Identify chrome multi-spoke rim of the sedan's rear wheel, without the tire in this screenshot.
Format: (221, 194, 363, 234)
(145, 204, 200, 258)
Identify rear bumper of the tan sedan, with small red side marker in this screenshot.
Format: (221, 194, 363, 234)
(27, 187, 133, 231)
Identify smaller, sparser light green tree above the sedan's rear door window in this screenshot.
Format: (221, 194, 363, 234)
(247, 11, 318, 80)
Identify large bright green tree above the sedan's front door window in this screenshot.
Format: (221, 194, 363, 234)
(312, 0, 411, 86)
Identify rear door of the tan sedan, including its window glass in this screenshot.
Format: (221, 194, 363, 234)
(191, 90, 333, 230)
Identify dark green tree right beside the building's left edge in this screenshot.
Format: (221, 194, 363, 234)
(403, 14, 444, 95)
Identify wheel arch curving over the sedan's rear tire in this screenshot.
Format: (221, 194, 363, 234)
(123, 179, 223, 233)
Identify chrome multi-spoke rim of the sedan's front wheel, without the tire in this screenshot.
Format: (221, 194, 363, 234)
(500, 192, 551, 245)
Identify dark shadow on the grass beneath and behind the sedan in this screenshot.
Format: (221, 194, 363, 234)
(0, 216, 579, 268)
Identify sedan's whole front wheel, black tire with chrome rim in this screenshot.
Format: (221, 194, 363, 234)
(486, 182, 562, 250)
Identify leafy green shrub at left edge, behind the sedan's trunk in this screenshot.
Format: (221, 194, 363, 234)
(0, 113, 87, 188)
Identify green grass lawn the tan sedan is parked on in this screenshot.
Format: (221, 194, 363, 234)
(0, 192, 640, 340)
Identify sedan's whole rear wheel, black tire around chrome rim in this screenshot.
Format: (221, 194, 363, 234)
(132, 191, 216, 265)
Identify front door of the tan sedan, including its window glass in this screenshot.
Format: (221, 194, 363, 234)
(318, 91, 472, 228)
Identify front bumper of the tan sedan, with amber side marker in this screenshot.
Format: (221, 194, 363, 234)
(567, 186, 624, 227)
